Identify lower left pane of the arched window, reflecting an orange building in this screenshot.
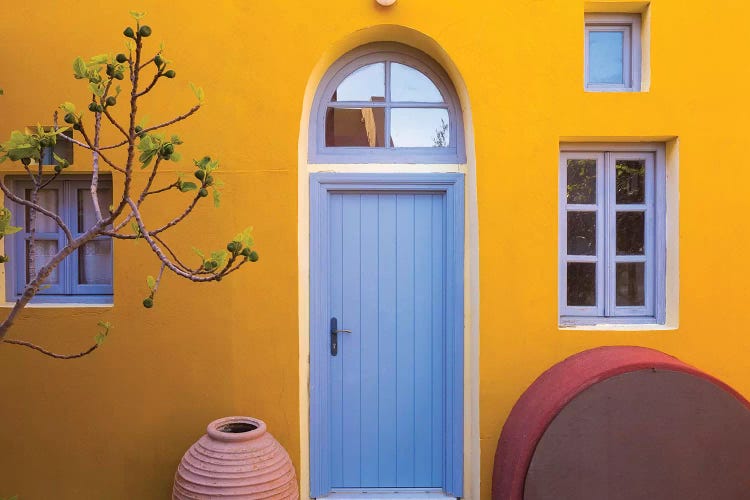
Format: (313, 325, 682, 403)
(326, 108, 385, 148)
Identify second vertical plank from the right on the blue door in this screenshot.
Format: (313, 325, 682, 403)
(413, 194, 439, 487)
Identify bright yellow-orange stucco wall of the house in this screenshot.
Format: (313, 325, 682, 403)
(0, 0, 750, 500)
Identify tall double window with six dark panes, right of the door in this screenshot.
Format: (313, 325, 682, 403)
(559, 145, 666, 325)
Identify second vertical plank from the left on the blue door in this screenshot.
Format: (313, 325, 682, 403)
(339, 193, 362, 488)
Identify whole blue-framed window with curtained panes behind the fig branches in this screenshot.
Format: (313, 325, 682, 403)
(6, 177, 113, 303)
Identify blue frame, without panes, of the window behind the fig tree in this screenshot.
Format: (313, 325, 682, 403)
(5, 176, 114, 304)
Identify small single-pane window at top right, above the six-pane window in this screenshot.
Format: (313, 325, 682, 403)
(584, 14, 641, 92)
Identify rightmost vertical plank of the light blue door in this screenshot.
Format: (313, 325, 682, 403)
(430, 194, 446, 484)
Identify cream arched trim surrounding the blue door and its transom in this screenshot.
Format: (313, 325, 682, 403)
(297, 24, 481, 499)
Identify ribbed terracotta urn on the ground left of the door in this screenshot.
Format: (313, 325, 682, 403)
(172, 417, 299, 500)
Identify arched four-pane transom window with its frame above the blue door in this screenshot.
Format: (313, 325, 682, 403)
(310, 44, 465, 163)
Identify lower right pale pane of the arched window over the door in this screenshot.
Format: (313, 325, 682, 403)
(391, 108, 450, 148)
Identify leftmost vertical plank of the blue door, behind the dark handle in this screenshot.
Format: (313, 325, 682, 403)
(328, 194, 344, 487)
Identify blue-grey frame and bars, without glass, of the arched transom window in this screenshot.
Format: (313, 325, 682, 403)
(308, 42, 466, 164)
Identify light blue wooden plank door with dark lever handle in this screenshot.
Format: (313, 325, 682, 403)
(311, 174, 462, 496)
